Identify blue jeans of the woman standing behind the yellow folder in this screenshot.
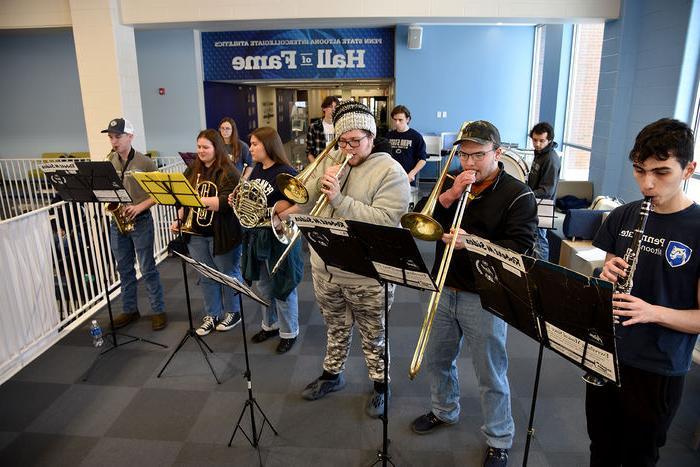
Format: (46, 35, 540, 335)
(187, 235, 243, 322)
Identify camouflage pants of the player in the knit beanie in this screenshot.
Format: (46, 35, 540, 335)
(313, 275, 396, 382)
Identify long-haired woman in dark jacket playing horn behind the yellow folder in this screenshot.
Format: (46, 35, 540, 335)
(170, 129, 243, 336)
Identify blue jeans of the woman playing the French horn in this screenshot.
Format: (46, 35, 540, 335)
(253, 261, 299, 339)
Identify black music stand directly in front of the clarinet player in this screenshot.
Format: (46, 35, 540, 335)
(466, 235, 620, 466)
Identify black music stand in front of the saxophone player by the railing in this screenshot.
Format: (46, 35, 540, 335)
(41, 161, 168, 381)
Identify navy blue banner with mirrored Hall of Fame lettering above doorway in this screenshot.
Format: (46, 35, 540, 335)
(202, 28, 394, 81)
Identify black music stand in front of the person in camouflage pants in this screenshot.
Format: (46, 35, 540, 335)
(290, 214, 437, 467)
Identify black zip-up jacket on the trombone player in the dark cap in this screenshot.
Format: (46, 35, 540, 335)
(433, 162, 538, 292)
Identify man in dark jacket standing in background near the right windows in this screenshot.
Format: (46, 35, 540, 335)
(527, 122, 561, 261)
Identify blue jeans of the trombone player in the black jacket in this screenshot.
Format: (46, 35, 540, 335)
(426, 287, 515, 449)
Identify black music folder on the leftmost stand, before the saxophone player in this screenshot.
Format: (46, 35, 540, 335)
(41, 160, 132, 203)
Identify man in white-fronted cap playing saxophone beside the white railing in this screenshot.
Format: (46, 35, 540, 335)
(102, 118, 168, 331)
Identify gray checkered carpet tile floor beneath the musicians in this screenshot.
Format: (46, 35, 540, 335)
(0, 242, 700, 467)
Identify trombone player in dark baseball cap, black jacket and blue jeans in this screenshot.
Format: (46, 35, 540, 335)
(411, 120, 537, 467)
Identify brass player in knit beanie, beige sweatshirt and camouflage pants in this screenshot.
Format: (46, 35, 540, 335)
(285, 101, 410, 417)
